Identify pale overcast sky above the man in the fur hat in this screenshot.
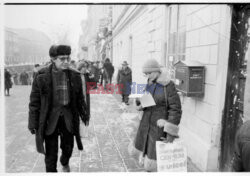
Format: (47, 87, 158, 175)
(4, 4, 87, 58)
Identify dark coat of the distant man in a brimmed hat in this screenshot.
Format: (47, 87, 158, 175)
(117, 67, 132, 95)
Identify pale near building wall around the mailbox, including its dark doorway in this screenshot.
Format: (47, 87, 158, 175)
(112, 4, 250, 171)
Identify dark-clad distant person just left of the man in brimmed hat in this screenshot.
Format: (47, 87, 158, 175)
(103, 58, 114, 89)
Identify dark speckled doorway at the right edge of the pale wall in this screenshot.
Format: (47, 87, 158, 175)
(220, 4, 250, 171)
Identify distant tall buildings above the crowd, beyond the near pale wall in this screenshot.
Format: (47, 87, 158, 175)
(79, 5, 112, 61)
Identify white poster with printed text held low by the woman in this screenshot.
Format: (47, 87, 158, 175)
(156, 141, 187, 172)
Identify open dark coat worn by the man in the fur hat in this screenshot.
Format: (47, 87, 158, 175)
(28, 65, 89, 154)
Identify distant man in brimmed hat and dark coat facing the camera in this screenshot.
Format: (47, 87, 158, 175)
(117, 61, 132, 105)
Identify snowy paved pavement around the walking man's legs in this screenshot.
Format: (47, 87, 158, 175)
(5, 86, 198, 173)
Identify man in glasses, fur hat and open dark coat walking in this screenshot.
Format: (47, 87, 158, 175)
(28, 45, 89, 172)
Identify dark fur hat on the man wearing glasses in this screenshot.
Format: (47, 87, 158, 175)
(49, 45, 71, 57)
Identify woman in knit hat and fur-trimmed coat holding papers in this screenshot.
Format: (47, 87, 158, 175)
(135, 59, 182, 171)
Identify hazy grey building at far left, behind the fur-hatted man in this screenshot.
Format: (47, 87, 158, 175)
(4, 28, 51, 65)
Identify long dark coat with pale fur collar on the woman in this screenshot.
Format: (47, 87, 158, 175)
(135, 74, 182, 160)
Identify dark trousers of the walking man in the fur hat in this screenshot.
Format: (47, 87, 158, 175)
(45, 116, 74, 172)
